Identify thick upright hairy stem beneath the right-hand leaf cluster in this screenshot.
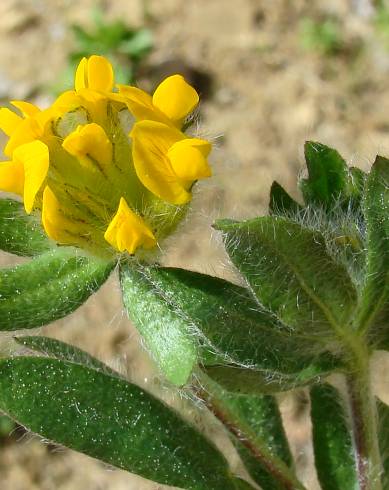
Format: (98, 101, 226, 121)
(346, 337, 382, 490)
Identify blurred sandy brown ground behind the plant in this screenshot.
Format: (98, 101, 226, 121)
(0, 0, 389, 490)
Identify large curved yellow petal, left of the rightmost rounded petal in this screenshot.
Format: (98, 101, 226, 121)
(130, 121, 191, 204)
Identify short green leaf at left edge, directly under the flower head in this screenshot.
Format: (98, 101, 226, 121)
(0, 199, 51, 256)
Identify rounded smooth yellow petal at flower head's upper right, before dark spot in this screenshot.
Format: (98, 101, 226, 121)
(153, 75, 199, 124)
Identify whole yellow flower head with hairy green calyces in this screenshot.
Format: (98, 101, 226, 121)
(0, 56, 211, 254)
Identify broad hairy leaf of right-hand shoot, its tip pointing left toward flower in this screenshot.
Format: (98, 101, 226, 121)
(216, 217, 357, 340)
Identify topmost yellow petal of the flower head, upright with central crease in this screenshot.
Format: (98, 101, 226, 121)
(74, 55, 114, 92)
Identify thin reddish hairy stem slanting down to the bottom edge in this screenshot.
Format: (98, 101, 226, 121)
(192, 382, 305, 490)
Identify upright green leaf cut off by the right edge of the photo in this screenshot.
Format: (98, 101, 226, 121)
(356, 156, 389, 336)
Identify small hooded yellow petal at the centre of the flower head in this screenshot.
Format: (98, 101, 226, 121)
(62, 123, 112, 164)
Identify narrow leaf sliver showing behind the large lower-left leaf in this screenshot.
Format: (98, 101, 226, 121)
(14, 335, 120, 376)
